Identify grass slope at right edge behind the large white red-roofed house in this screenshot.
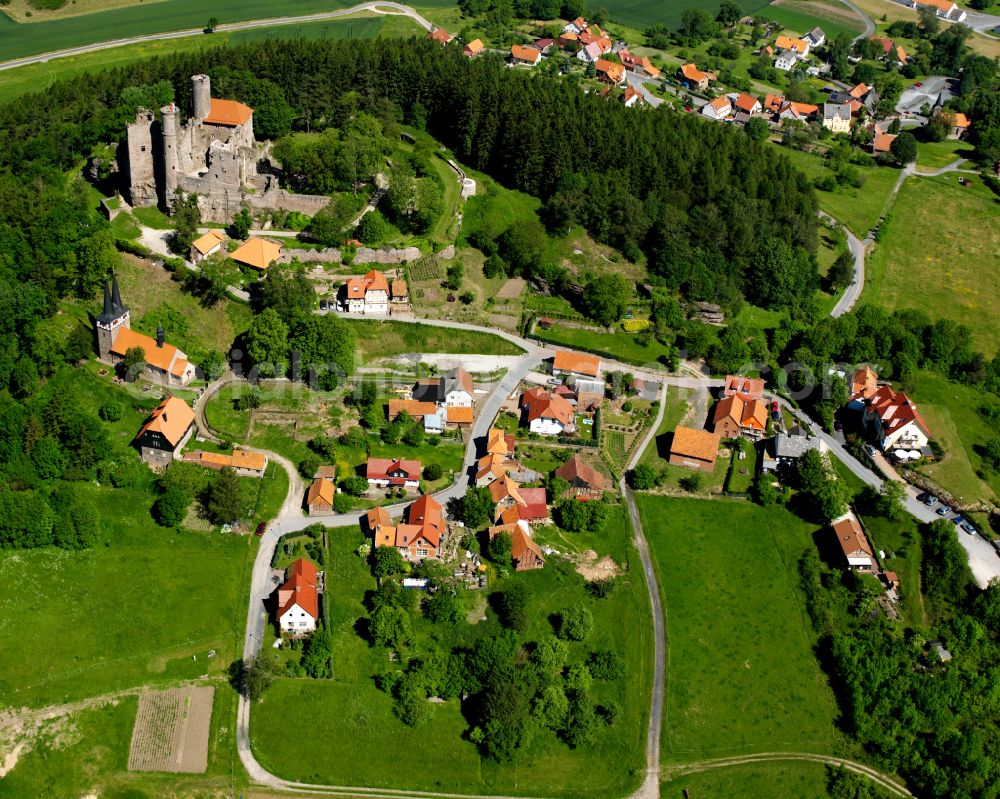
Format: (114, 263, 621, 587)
(910, 372, 1000, 503)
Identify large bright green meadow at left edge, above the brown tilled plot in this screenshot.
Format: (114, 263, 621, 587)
(0, 476, 256, 706)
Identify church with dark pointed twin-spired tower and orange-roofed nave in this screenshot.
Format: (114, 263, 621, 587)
(94, 275, 195, 386)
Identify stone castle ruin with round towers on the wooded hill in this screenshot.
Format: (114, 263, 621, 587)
(122, 75, 329, 222)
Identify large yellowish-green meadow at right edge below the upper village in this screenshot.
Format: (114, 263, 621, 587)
(861, 175, 1000, 358)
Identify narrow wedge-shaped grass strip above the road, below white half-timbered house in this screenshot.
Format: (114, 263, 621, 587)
(348, 319, 521, 362)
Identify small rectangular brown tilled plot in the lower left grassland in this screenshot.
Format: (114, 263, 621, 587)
(128, 687, 215, 774)
